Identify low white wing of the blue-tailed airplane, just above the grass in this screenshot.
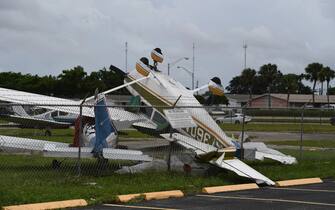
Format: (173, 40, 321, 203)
(0, 135, 152, 161)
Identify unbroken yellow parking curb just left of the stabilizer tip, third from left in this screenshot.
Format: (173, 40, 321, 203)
(202, 183, 259, 194)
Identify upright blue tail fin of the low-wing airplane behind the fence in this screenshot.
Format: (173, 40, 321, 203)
(93, 94, 117, 154)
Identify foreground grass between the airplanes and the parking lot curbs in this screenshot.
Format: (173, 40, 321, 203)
(0, 150, 335, 206)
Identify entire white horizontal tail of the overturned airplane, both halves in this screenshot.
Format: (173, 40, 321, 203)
(161, 133, 275, 185)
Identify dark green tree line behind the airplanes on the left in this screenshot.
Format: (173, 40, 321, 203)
(0, 66, 128, 98)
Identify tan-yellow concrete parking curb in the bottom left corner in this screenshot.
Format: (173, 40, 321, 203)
(2, 199, 87, 210)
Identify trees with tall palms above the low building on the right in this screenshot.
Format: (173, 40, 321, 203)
(226, 63, 335, 104)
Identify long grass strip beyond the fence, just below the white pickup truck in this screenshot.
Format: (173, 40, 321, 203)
(220, 123, 335, 133)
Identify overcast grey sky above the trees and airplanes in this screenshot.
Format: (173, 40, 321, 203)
(0, 0, 335, 89)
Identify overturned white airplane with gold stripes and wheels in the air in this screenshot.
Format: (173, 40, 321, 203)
(116, 48, 296, 185)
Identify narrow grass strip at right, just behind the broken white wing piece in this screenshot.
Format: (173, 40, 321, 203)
(267, 140, 335, 148)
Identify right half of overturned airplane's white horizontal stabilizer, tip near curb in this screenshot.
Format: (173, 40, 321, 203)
(212, 154, 275, 185)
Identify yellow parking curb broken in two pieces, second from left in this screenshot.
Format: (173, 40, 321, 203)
(116, 190, 184, 203)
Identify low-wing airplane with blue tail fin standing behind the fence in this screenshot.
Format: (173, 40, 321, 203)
(0, 94, 152, 167)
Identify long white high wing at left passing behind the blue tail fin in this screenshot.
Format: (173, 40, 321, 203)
(0, 88, 143, 130)
